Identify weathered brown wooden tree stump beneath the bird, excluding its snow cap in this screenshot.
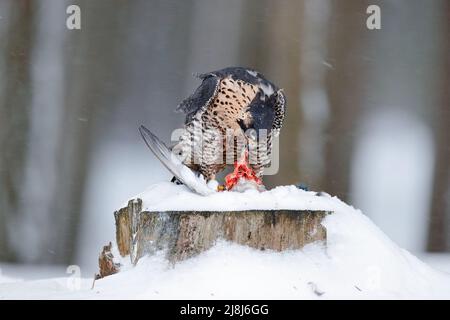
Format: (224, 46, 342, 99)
(114, 199, 330, 264)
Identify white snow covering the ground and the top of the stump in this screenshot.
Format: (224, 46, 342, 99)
(0, 183, 450, 299)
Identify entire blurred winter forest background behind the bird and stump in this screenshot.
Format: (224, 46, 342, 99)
(0, 0, 450, 272)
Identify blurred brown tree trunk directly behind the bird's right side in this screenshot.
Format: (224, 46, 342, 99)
(241, 0, 303, 186)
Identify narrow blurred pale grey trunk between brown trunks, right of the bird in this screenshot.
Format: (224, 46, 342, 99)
(299, 0, 332, 190)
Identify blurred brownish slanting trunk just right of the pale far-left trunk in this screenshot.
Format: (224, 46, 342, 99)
(51, 0, 132, 263)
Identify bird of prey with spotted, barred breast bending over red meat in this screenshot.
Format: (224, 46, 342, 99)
(141, 67, 286, 190)
